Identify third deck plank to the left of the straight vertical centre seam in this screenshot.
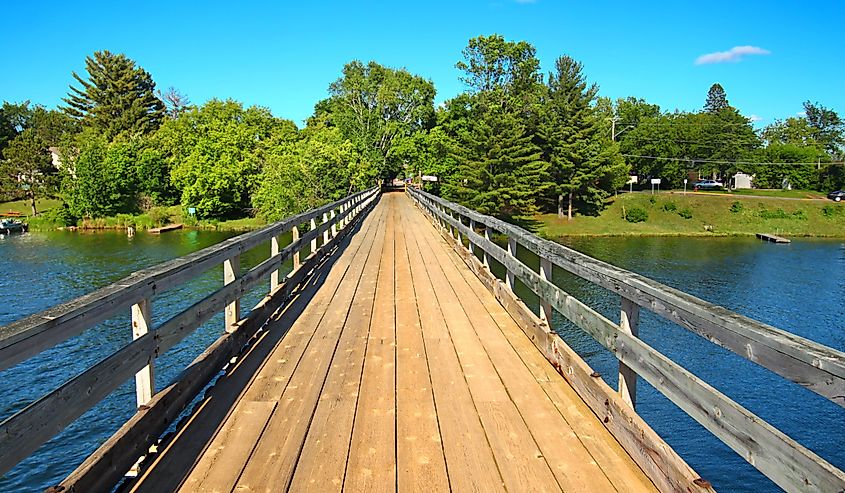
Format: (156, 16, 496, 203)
(236, 203, 383, 491)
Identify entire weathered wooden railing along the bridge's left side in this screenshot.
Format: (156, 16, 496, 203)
(0, 188, 379, 491)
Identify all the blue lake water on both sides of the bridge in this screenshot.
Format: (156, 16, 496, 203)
(0, 231, 845, 492)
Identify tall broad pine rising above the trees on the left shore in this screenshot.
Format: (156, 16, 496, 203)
(63, 51, 164, 139)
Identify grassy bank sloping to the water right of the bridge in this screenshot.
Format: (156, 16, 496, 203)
(535, 192, 845, 238)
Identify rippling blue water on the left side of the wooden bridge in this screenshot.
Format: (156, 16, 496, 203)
(0, 230, 290, 491)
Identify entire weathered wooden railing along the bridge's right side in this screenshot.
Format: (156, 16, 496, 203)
(408, 188, 845, 492)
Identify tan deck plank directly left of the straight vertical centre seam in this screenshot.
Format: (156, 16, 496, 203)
(344, 194, 399, 492)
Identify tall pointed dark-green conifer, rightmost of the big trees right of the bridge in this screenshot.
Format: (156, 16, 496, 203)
(540, 56, 628, 219)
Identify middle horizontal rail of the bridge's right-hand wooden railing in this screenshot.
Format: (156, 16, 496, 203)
(408, 187, 845, 491)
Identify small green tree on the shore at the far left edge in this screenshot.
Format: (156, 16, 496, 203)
(0, 128, 56, 216)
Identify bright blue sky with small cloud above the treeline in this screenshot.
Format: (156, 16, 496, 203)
(0, 0, 845, 125)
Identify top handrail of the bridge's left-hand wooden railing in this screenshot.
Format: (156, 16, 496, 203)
(0, 189, 377, 370)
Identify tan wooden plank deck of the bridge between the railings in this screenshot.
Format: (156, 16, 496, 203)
(124, 193, 654, 492)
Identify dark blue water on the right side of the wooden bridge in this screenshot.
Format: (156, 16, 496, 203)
(555, 238, 845, 492)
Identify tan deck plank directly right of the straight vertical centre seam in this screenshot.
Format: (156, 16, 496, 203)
(395, 206, 449, 491)
